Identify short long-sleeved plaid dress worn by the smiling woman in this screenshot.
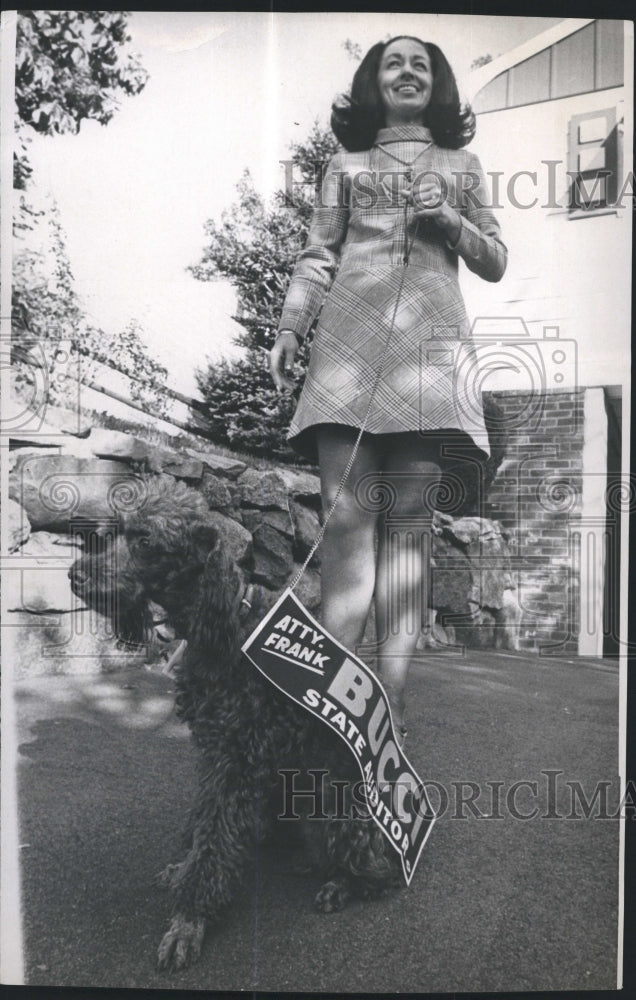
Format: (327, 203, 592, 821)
(280, 125, 506, 461)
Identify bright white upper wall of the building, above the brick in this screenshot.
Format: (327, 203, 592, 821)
(462, 51, 633, 389)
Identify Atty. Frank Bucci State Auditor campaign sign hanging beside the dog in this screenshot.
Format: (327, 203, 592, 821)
(242, 589, 435, 885)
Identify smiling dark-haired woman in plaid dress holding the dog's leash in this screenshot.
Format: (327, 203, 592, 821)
(270, 36, 506, 738)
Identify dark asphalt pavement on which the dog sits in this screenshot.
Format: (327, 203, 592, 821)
(8, 651, 619, 993)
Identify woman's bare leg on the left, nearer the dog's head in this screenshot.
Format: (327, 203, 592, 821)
(316, 425, 381, 652)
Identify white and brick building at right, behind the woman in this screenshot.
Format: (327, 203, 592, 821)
(463, 19, 634, 656)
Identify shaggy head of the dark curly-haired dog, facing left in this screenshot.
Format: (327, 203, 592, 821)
(69, 476, 224, 642)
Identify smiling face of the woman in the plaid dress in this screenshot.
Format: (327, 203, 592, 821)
(378, 38, 433, 126)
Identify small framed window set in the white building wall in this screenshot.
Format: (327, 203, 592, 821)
(568, 108, 618, 213)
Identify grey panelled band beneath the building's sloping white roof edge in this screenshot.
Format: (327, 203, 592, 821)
(473, 21, 624, 114)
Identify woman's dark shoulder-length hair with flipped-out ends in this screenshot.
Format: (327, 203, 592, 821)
(331, 35, 475, 153)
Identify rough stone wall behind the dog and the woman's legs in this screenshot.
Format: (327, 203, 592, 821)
(3, 414, 518, 676)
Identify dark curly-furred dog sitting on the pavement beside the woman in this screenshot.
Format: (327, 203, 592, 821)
(69, 476, 399, 968)
